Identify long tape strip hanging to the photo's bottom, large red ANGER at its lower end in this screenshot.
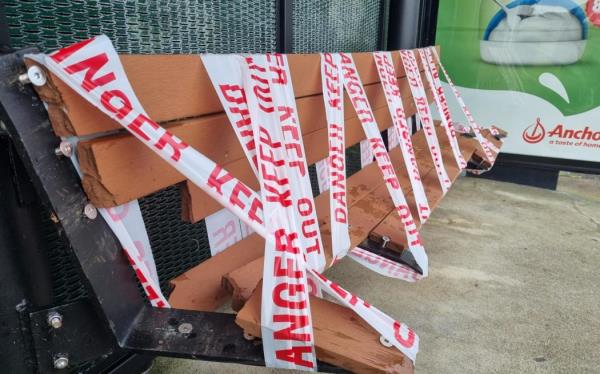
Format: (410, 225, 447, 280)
(243, 55, 316, 370)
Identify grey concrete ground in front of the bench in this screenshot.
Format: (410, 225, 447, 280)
(152, 174, 600, 374)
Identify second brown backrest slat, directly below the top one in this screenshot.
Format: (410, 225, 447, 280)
(77, 74, 415, 207)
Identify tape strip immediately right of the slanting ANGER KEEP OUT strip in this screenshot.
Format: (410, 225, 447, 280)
(373, 52, 431, 223)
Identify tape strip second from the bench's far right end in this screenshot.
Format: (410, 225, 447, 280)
(419, 48, 467, 170)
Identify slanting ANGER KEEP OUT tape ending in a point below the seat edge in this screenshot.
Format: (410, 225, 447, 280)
(340, 53, 428, 277)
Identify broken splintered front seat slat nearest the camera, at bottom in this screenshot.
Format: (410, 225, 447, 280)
(235, 288, 414, 374)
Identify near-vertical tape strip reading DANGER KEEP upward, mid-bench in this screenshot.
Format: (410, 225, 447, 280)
(321, 53, 350, 263)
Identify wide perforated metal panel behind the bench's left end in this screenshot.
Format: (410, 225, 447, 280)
(3, 0, 277, 53)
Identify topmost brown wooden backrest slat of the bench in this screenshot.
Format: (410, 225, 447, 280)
(26, 48, 440, 136)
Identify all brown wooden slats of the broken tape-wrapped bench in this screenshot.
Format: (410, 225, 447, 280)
(26, 44, 506, 373)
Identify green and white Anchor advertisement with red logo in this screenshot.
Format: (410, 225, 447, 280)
(436, 0, 600, 162)
